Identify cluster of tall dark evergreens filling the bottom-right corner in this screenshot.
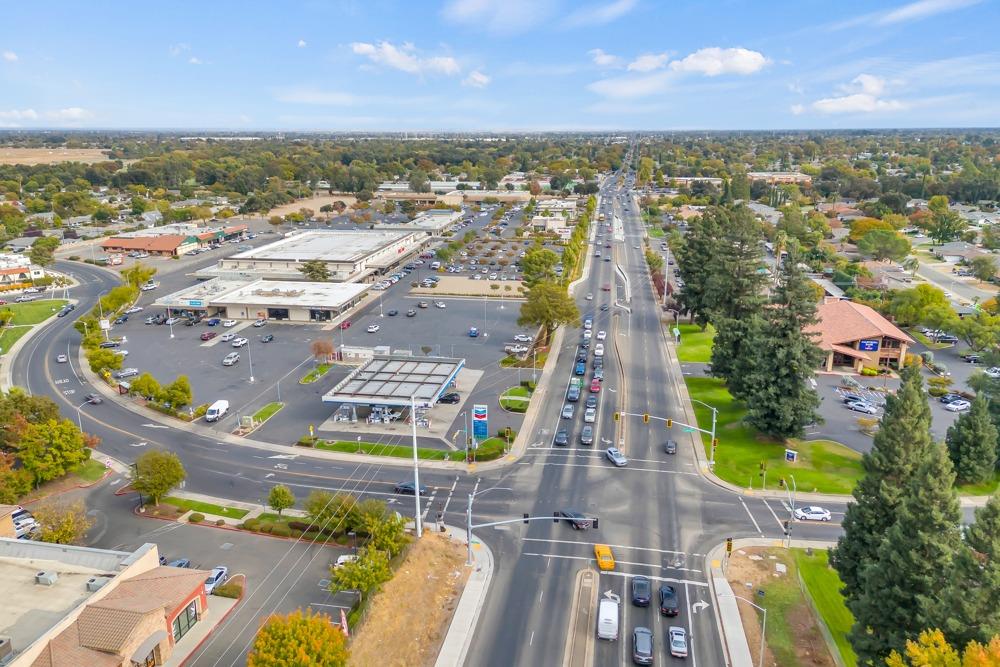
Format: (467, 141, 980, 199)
(831, 366, 1000, 664)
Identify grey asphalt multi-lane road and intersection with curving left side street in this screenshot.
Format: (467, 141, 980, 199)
(12, 159, 844, 665)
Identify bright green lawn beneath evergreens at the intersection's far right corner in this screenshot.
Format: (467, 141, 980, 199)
(688, 377, 861, 493)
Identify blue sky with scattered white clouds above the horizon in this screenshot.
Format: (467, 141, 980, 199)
(0, 0, 1000, 131)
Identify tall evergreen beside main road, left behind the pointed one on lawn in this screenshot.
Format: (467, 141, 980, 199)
(704, 206, 766, 398)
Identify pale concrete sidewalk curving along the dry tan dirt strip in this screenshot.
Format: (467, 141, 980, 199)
(434, 526, 493, 667)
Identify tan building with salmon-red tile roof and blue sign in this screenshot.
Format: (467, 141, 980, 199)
(806, 298, 913, 372)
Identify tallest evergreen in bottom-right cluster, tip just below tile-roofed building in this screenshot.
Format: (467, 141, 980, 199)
(830, 366, 933, 605)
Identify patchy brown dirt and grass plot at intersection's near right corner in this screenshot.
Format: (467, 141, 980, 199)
(726, 549, 835, 667)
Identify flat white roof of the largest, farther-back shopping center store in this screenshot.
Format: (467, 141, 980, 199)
(227, 229, 415, 262)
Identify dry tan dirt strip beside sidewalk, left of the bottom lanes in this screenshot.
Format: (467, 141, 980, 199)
(348, 533, 468, 667)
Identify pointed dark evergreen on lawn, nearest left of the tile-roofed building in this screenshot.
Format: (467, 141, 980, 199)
(740, 241, 823, 438)
